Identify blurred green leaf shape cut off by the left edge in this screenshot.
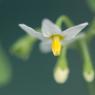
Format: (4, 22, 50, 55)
(0, 45, 12, 87)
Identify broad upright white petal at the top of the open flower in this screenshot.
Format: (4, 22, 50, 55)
(42, 19, 61, 37)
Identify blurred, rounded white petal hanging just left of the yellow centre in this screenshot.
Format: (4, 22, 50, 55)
(39, 40, 51, 53)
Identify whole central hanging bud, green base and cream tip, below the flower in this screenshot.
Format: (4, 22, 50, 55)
(54, 47, 69, 84)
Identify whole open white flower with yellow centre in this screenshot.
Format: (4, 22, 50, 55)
(19, 19, 88, 56)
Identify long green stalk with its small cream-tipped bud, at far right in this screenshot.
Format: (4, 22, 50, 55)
(80, 40, 95, 82)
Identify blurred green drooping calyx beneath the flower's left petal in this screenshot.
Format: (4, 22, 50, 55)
(10, 35, 36, 60)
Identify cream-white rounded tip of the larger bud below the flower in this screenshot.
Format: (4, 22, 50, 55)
(54, 67, 69, 84)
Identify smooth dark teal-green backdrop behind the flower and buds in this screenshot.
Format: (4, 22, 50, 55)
(0, 0, 95, 95)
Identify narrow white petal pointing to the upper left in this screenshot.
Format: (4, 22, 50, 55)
(19, 24, 43, 40)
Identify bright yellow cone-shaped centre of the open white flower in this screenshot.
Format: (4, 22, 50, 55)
(51, 35, 63, 56)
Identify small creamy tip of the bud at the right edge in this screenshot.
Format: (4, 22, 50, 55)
(83, 70, 95, 82)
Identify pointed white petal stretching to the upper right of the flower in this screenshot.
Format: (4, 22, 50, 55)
(62, 23, 88, 40)
